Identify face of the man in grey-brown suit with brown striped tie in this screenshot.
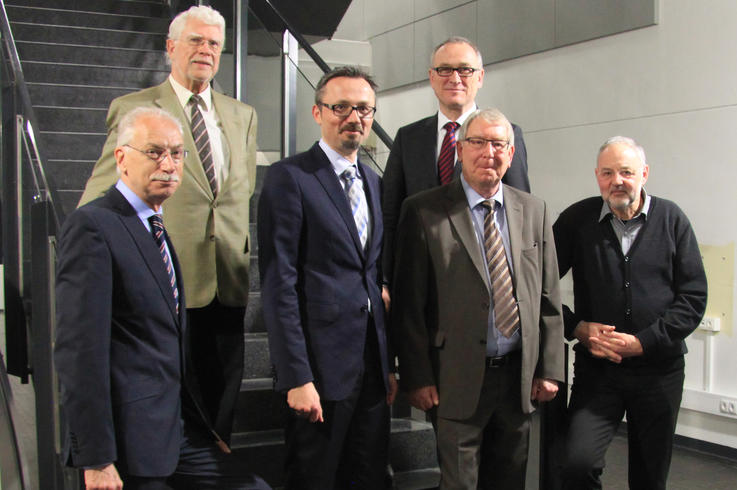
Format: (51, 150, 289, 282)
(456, 117, 514, 199)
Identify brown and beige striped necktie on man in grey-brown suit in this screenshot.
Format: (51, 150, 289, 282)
(481, 200, 519, 338)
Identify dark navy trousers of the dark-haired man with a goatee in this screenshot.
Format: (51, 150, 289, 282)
(285, 319, 390, 490)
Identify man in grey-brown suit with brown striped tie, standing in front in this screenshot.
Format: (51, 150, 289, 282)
(391, 109, 563, 489)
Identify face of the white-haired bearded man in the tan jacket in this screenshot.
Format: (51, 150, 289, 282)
(166, 18, 223, 94)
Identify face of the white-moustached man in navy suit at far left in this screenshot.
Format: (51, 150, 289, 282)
(115, 116, 184, 211)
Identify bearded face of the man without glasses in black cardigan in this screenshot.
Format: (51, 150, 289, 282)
(596, 143, 650, 220)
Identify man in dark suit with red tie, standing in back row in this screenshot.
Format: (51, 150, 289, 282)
(382, 37, 530, 302)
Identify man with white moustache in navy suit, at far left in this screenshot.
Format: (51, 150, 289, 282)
(55, 108, 269, 490)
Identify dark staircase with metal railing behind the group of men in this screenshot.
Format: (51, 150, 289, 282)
(5, 0, 439, 490)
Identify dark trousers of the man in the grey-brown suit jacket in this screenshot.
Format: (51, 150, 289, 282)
(436, 354, 530, 490)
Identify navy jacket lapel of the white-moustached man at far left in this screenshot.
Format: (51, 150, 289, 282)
(108, 187, 181, 326)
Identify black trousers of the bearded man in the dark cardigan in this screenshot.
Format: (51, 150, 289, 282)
(563, 354, 684, 490)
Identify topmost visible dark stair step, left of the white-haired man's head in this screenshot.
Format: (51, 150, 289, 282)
(6, 2, 169, 32)
